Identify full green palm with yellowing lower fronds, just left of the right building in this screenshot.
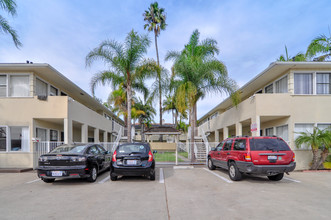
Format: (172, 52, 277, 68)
(166, 30, 239, 161)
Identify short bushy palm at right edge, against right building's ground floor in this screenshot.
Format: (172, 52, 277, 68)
(295, 127, 331, 170)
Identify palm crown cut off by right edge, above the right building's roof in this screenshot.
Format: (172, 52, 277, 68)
(306, 28, 331, 61)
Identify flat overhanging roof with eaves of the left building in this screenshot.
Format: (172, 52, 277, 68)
(0, 63, 124, 124)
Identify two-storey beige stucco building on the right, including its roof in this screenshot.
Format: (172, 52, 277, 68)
(198, 62, 331, 169)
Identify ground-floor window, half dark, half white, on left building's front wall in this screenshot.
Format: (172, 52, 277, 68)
(9, 127, 29, 151)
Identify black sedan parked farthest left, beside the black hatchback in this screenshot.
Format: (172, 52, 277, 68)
(37, 144, 111, 183)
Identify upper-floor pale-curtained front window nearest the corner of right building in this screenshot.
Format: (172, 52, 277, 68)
(294, 73, 313, 94)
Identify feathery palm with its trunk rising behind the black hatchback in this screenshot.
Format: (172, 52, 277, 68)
(85, 30, 150, 142)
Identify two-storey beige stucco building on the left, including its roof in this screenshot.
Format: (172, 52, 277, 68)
(0, 63, 124, 168)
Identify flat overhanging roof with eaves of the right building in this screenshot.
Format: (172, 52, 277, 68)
(198, 62, 331, 121)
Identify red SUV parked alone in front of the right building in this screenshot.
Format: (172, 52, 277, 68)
(208, 137, 296, 181)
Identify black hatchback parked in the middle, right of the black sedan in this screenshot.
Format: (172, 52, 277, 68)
(110, 143, 156, 181)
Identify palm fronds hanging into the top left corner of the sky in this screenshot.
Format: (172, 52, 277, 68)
(0, 0, 22, 48)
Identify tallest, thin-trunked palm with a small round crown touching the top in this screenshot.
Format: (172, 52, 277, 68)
(143, 2, 167, 126)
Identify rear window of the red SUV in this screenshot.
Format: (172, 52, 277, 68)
(249, 138, 290, 151)
